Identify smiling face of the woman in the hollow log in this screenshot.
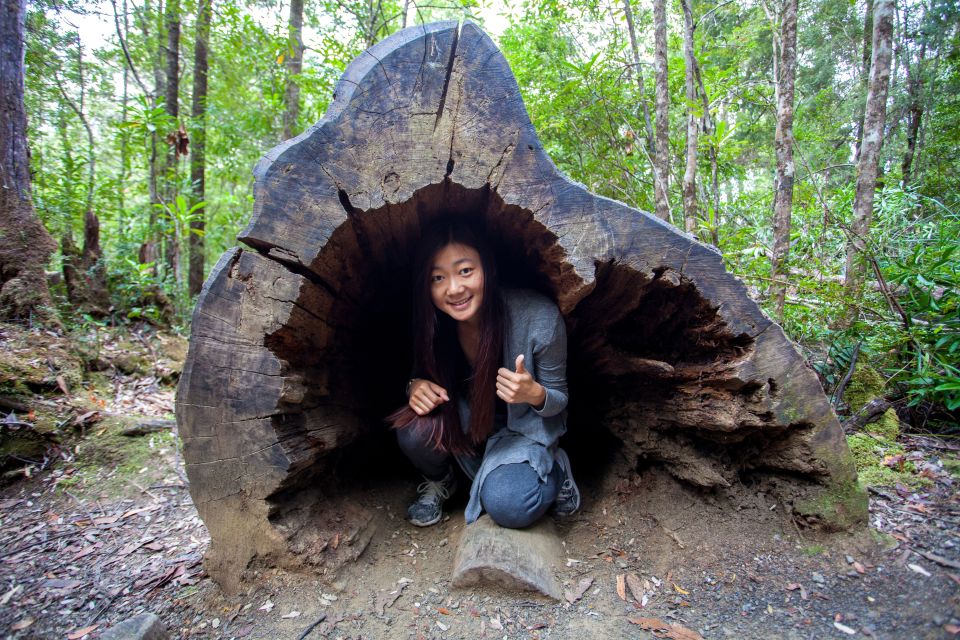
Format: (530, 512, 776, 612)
(430, 243, 483, 323)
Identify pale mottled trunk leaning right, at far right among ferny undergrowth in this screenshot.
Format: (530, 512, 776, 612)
(844, 0, 894, 320)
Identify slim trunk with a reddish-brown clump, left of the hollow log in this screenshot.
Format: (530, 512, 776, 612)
(162, 0, 185, 280)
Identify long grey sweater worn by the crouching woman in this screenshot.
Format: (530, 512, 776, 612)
(458, 289, 567, 524)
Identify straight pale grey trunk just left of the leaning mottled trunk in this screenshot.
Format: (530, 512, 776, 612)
(770, 0, 797, 319)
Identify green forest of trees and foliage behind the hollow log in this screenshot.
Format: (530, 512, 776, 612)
(0, 0, 960, 436)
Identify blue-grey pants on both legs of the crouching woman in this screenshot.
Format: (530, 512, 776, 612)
(397, 427, 563, 529)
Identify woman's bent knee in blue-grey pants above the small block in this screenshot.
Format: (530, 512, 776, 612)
(480, 463, 559, 529)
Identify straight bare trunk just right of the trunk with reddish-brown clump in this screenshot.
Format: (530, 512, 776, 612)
(187, 0, 212, 295)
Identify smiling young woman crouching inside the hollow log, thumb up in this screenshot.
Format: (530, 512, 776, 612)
(391, 221, 580, 528)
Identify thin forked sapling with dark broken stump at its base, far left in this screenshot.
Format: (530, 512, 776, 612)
(54, 36, 110, 317)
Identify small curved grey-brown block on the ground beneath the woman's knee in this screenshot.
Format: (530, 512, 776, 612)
(452, 515, 563, 600)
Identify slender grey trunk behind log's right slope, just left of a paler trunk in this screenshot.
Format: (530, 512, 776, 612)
(653, 0, 670, 220)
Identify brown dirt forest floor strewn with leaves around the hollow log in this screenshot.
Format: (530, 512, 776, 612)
(0, 325, 960, 640)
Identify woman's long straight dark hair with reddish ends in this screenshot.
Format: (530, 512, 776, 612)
(387, 218, 504, 453)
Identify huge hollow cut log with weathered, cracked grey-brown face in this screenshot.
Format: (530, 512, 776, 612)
(177, 22, 865, 590)
